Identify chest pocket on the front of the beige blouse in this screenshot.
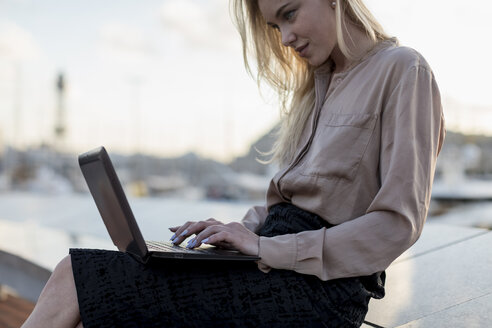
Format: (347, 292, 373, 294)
(299, 114, 378, 181)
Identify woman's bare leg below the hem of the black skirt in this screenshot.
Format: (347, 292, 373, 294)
(22, 255, 82, 328)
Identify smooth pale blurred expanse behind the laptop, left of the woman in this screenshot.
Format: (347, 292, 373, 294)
(0, 192, 256, 270)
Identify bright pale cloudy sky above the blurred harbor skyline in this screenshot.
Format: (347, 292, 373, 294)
(0, 0, 492, 161)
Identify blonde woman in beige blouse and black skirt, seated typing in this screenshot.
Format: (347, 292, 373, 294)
(25, 0, 444, 327)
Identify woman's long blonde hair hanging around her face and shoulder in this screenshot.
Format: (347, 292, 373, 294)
(230, 0, 389, 165)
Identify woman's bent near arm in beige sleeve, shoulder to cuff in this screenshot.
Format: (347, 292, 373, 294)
(259, 65, 444, 280)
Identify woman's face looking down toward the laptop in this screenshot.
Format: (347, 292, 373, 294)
(258, 0, 337, 66)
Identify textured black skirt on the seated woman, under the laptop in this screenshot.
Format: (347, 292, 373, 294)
(70, 204, 385, 328)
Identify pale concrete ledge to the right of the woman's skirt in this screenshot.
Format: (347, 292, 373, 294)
(364, 222, 492, 328)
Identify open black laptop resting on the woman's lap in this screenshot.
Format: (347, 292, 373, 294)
(79, 147, 260, 263)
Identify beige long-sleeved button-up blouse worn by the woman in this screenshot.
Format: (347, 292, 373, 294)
(242, 39, 445, 280)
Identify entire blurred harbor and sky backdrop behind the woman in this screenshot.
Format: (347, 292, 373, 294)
(0, 0, 492, 269)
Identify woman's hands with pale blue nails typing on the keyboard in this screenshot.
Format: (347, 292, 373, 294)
(170, 219, 260, 255)
